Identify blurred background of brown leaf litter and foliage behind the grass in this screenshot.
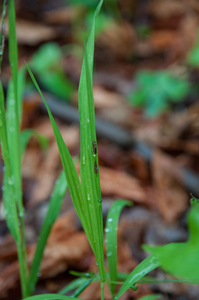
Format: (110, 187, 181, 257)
(0, 0, 199, 300)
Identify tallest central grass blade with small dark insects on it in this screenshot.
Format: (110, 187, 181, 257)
(78, 0, 105, 282)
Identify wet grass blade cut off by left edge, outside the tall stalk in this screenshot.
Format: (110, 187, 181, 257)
(0, 82, 19, 242)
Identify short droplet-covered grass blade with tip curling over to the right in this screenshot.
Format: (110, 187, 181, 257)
(105, 200, 133, 294)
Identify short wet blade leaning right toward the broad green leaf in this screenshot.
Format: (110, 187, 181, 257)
(115, 255, 160, 300)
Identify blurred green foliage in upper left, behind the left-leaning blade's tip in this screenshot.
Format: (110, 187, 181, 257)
(30, 43, 75, 101)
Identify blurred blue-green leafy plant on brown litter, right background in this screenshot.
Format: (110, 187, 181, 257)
(128, 71, 190, 118)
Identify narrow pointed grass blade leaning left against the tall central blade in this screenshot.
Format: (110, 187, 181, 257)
(27, 65, 92, 251)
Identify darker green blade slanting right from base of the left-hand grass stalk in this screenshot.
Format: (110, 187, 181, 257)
(30, 172, 67, 292)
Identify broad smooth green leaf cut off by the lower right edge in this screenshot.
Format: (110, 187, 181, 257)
(144, 204, 199, 281)
